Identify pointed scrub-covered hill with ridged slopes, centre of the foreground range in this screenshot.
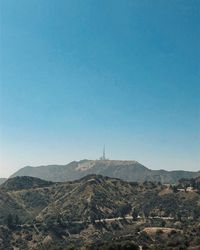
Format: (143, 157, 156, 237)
(37, 175, 139, 224)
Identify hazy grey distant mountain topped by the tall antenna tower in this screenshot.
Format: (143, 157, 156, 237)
(11, 160, 200, 184)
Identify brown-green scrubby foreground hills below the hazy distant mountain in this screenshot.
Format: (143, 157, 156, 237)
(0, 175, 200, 250)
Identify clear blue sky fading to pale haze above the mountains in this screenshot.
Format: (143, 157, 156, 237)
(0, 0, 200, 177)
